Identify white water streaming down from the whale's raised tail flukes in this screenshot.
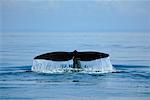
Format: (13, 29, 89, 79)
(32, 57, 115, 73)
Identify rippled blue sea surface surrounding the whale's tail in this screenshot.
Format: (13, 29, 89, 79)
(0, 32, 150, 100)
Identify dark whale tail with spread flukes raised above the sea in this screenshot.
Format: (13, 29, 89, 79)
(34, 50, 109, 68)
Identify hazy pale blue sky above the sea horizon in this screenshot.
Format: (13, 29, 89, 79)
(0, 0, 150, 32)
